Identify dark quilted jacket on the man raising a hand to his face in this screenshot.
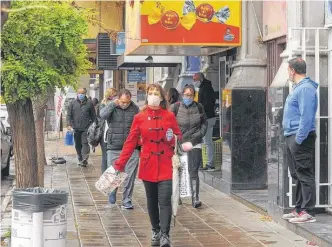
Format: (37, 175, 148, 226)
(100, 102, 139, 150)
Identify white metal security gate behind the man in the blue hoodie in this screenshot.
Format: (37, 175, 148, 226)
(287, 28, 332, 208)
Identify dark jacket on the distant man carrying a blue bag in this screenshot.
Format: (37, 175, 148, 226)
(67, 98, 96, 131)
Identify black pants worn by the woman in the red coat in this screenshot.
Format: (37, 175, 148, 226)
(143, 180, 172, 235)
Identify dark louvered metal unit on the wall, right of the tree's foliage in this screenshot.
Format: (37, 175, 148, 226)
(97, 33, 119, 70)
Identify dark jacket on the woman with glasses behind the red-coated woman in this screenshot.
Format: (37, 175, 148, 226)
(170, 102, 207, 146)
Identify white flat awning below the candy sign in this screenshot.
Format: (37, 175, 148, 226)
(118, 55, 183, 69)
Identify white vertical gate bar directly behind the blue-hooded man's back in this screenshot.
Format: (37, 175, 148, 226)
(315, 29, 320, 205)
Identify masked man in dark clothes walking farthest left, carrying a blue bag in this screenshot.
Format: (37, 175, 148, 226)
(67, 88, 96, 167)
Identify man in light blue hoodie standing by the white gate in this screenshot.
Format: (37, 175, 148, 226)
(282, 58, 318, 223)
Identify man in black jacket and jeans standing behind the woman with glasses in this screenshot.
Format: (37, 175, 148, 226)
(193, 73, 216, 171)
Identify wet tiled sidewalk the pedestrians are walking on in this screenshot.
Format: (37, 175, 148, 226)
(2, 142, 308, 247)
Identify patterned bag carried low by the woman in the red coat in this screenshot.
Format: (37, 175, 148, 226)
(95, 166, 128, 196)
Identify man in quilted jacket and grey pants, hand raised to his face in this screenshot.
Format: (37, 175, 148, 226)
(100, 89, 139, 209)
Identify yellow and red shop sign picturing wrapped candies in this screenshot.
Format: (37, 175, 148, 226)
(140, 0, 241, 46)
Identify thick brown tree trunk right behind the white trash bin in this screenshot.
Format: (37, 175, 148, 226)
(7, 99, 38, 188)
